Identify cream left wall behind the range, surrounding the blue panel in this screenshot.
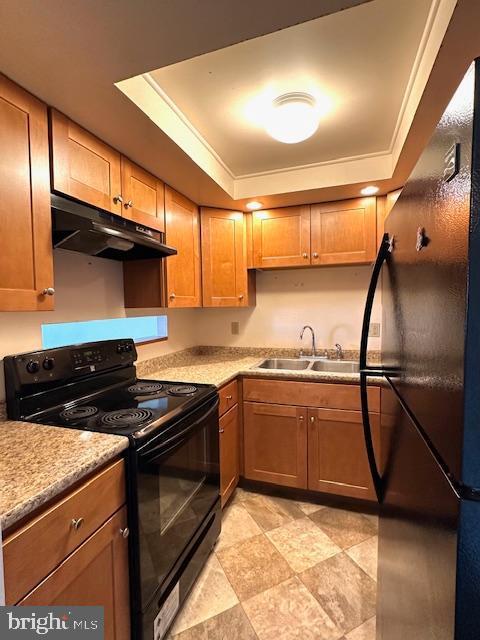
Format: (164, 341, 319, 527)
(0, 249, 198, 401)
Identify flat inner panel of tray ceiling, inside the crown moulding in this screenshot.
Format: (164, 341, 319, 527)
(150, 0, 432, 177)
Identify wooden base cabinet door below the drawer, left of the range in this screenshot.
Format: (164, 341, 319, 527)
(18, 507, 130, 640)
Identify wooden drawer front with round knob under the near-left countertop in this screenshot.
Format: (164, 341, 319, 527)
(3, 460, 125, 604)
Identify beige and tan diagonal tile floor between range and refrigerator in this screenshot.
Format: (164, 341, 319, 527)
(169, 489, 378, 640)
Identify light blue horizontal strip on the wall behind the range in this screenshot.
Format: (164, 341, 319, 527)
(42, 316, 168, 349)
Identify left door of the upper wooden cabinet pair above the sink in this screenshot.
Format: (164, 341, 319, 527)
(252, 206, 310, 268)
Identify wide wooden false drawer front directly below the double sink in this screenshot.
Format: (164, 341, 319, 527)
(243, 378, 380, 413)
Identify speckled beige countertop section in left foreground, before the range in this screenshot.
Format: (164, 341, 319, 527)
(0, 420, 128, 531)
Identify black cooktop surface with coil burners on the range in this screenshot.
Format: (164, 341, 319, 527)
(35, 380, 215, 437)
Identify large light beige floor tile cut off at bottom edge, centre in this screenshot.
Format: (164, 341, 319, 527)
(243, 577, 342, 640)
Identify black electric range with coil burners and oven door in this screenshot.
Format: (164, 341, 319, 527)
(4, 339, 221, 640)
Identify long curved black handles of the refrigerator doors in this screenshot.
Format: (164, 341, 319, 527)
(360, 233, 393, 502)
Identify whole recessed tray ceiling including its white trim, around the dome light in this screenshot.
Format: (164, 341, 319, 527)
(116, 0, 456, 199)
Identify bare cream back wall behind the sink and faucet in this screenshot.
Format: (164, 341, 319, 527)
(199, 266, 381, 356)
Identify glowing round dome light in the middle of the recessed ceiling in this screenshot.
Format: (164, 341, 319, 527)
(265, 91, 321, 144)
